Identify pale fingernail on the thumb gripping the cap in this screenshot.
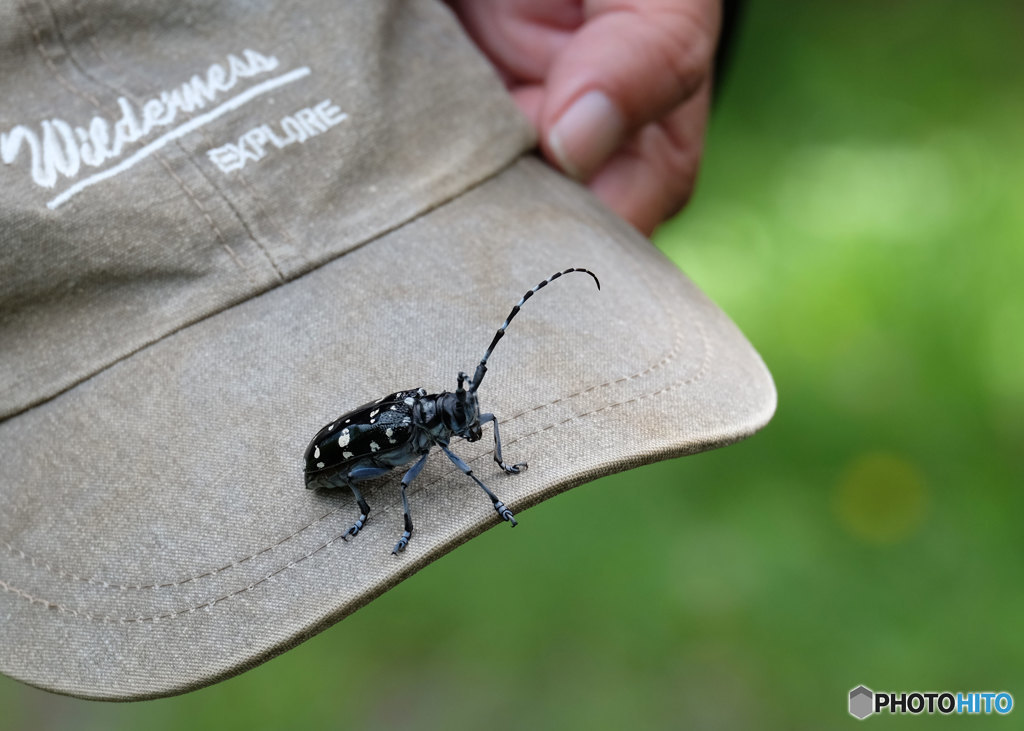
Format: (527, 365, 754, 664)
(548, 90, 626, 180)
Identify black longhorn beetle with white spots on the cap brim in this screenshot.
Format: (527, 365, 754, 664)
(305, 267, 601, 555)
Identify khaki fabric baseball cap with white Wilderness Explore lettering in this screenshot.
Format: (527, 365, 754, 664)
(0, 0, 775, 700)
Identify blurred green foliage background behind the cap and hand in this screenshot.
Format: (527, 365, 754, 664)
(0, 0, 1024, 729)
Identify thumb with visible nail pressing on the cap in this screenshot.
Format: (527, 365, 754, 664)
(540, 0, 720, 180)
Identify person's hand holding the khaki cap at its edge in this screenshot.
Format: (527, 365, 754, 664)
(450, 0, 721, 234)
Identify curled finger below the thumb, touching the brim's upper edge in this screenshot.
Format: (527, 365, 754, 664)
(589, 79, 711, 235)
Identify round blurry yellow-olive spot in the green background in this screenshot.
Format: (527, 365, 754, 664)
(836, 453, 926, 545)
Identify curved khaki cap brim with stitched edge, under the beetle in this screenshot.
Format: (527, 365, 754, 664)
(0, 158, 775, 699)
